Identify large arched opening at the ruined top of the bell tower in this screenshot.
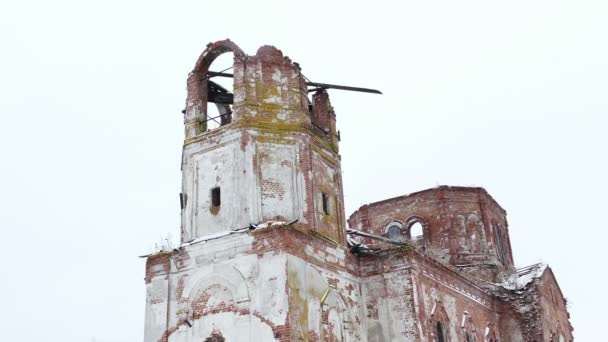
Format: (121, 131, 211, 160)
(203, 52, 234, 130)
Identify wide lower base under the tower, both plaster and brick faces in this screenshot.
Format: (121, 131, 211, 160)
(145, 226, 365, 341)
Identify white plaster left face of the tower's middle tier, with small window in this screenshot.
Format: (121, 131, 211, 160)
(182, 130, 259, 242)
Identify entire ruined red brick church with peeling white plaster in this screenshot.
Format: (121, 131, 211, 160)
(145, 40, 572, 342)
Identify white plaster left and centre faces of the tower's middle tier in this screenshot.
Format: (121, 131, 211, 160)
(182, 128, 306, 242)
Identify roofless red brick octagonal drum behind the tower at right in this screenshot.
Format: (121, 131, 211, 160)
(349, 186, 510, 281)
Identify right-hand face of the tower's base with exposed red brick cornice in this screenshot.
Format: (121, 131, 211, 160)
(253, 224, 364, 341)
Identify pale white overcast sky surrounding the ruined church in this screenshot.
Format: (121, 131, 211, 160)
(0, 0, 608, 342)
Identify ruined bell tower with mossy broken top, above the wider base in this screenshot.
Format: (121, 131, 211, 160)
(180, 40, 345, 243)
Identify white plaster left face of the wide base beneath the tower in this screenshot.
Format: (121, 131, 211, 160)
(144, 233, 289, 342)
